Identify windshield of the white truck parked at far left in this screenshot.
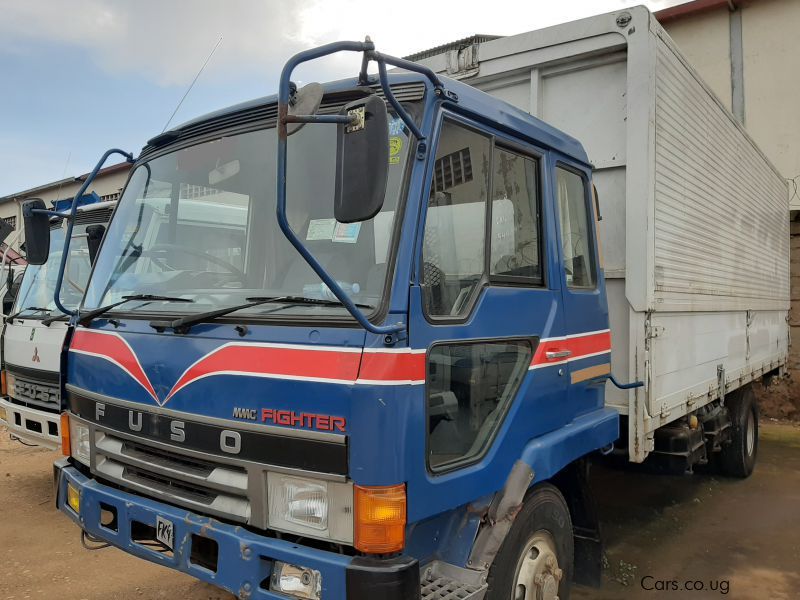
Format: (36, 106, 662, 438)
(14, 222, 92, 319)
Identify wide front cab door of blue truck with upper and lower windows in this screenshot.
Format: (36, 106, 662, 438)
(409, 115, 570, 520)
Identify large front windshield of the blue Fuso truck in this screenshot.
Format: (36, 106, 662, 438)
(84, 110, 416, 317)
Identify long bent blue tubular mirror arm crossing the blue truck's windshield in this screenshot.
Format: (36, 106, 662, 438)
(275, 41, 405, 343)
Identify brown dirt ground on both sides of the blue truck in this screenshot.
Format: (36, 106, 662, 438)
(0, 423, 800, 600)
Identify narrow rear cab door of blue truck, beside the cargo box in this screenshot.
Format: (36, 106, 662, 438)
(553, 161, 611, 416)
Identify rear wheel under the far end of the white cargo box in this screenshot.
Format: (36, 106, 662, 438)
(719, 385, 758, 479)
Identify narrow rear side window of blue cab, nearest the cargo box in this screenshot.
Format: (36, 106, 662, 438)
(556, 167, 597, 289)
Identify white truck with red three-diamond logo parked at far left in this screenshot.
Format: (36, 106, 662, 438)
(0, 201, 116, 449)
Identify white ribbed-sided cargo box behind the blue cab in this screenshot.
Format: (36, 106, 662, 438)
(411, 7, 789, 462)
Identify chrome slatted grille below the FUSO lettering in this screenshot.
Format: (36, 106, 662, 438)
(92, 430, 252, 523)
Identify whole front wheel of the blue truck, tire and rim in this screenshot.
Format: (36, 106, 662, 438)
(486, 483, 574, 600)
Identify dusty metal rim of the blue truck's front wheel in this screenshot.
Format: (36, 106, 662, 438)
(511, 531, 564, 600)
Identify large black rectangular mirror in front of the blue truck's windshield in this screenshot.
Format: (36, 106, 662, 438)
(333, 95, 389, 223)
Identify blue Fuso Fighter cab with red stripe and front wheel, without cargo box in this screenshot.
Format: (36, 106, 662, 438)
(23, 19, 784, 600)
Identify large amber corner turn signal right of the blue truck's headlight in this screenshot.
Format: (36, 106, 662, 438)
(355, 484, 406, 554)
